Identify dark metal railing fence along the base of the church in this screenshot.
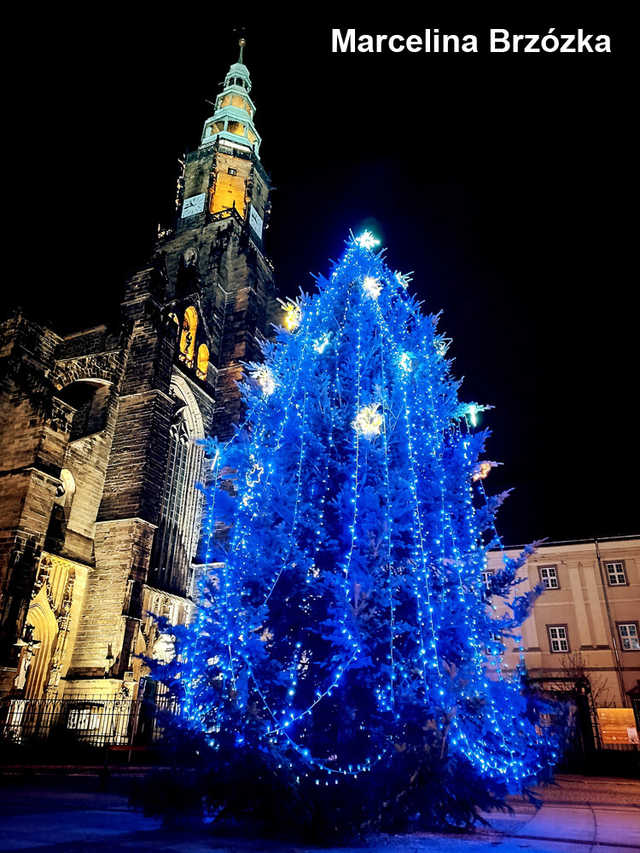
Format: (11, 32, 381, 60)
(0, 695, 177, 747)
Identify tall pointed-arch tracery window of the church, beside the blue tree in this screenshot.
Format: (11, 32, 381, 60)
(151, 377, 204, 595)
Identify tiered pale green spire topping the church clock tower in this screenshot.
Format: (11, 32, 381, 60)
(200, 38, 262, 156)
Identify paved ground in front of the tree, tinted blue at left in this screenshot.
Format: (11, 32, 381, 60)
(0, 776, 640, 853)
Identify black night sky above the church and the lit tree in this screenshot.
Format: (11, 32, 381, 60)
(4, 13, 640, 543)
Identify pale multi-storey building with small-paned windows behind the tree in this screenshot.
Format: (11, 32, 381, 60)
(487, 537, 640, 746)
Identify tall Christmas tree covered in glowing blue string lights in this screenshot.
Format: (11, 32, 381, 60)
(158, 232, 557, 829)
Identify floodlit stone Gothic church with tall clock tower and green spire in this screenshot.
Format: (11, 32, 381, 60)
(0, 41, 278, 704)
